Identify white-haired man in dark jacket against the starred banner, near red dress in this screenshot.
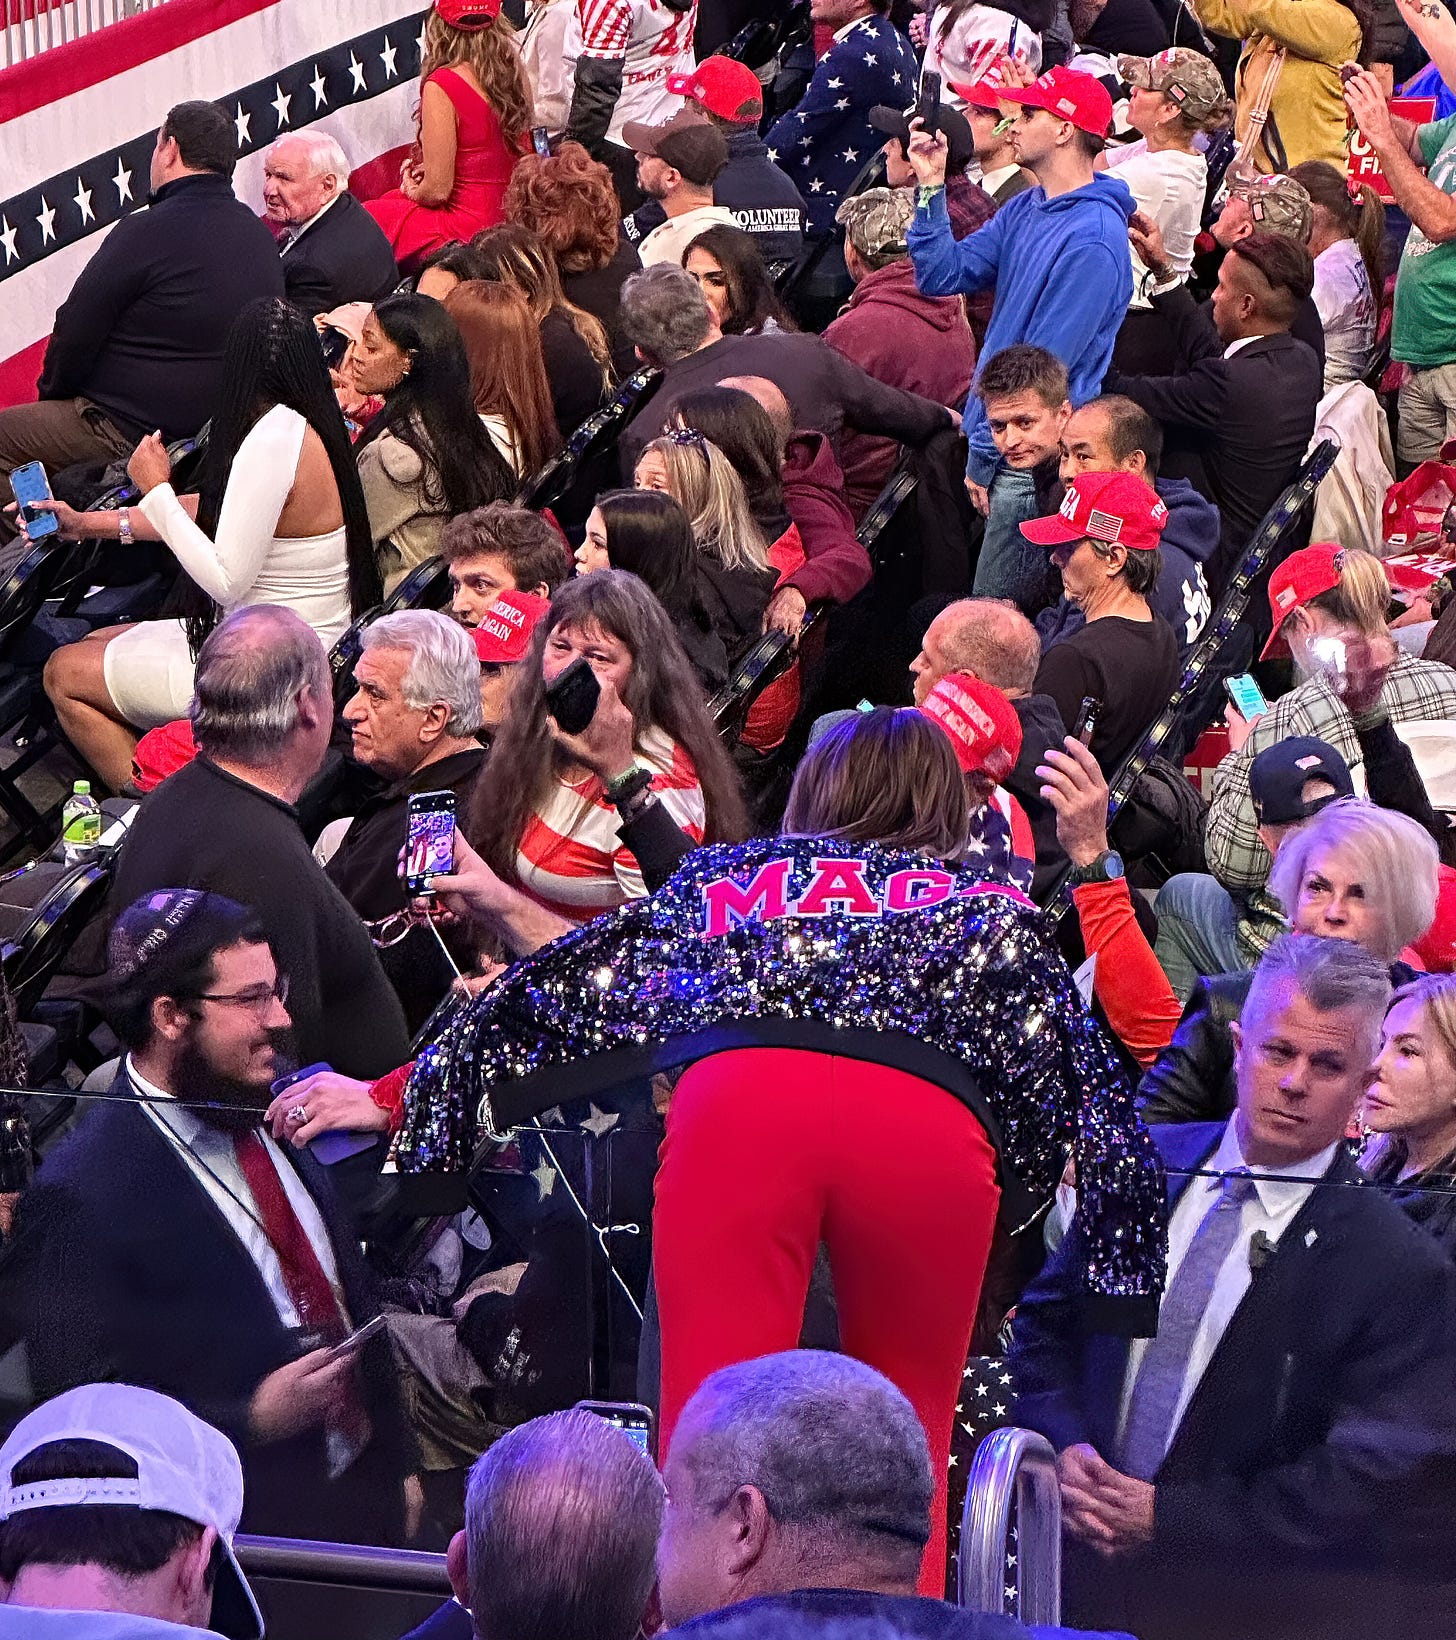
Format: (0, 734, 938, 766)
(262, 131, 400, 318)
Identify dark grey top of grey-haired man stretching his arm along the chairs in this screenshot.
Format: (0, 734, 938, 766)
(618, 330, 951, 484)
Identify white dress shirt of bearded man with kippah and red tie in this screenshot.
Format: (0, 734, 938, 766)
(126, 1055, 353, 1330)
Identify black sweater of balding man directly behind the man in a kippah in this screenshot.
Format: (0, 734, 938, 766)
(110, 756, 410, 1081)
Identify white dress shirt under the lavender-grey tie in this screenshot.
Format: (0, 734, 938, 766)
(1117, 1118, 1340, 1443)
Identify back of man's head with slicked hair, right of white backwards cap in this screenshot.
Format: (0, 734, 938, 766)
(466, 1410, 662, 1640)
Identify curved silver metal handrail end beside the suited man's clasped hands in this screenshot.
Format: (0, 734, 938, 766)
(958, 1428, 1061, 1627)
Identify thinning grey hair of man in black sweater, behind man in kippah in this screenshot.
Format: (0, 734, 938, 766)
(189, 604, 330, 763)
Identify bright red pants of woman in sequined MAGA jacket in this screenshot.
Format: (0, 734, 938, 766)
(653, 1048, 1000, 1596)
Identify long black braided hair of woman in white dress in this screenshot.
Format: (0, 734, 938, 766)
(184, 297, 380, 656)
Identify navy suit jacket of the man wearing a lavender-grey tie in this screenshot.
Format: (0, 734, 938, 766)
(1012, 1123, 1456, 1640)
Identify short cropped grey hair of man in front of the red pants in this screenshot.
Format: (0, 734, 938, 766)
(674, 1350, 931, 1561)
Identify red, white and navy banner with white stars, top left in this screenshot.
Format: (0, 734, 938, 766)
(0, 0, 425, 407)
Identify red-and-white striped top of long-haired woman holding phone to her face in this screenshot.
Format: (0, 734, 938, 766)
(516, 728, 707, 923)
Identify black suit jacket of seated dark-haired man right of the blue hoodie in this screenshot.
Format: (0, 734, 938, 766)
(1102, 285, 1323, 594)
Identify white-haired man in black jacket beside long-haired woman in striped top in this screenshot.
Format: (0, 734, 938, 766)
(315, 610, 485, 1032)
